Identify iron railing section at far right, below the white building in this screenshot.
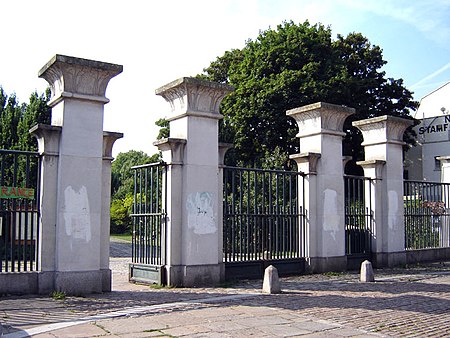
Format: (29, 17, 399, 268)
(403, 181, 450, 250)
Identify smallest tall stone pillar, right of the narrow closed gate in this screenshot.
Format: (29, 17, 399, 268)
(353, 115, 413, 266)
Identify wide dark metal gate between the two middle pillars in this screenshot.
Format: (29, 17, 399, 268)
(223, 167, 306, 279)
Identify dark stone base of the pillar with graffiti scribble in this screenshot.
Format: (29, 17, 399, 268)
(166, 263, 225, 287)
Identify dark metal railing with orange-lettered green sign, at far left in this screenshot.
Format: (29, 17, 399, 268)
(0, 150, 40, 273)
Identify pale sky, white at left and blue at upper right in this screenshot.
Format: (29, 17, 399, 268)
(0, 0, 450, 155)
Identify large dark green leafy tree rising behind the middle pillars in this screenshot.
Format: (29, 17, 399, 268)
(199, 21, 416, 165)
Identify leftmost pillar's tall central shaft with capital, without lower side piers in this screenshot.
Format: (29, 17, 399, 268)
(39, 55, 122, 294)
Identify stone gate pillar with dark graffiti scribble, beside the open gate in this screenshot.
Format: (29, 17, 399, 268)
(156, 78, 232, 286)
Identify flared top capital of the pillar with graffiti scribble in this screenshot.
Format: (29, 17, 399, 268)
(155, 77, 233, 121)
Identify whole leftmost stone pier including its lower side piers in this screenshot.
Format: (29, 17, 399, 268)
(33, 55, 122, 294)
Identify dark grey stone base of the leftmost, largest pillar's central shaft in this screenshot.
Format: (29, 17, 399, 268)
(55, 270, 103, 296)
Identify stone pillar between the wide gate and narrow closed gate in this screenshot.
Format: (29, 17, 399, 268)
(286, 102, 355, 272)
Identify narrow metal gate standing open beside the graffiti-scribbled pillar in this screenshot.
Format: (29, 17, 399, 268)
(129, 163, 167, 284)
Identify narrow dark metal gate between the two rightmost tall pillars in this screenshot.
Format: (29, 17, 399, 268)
(344, 175, 373, 269)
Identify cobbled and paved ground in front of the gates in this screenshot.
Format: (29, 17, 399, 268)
(0, 241, 450, 338)
